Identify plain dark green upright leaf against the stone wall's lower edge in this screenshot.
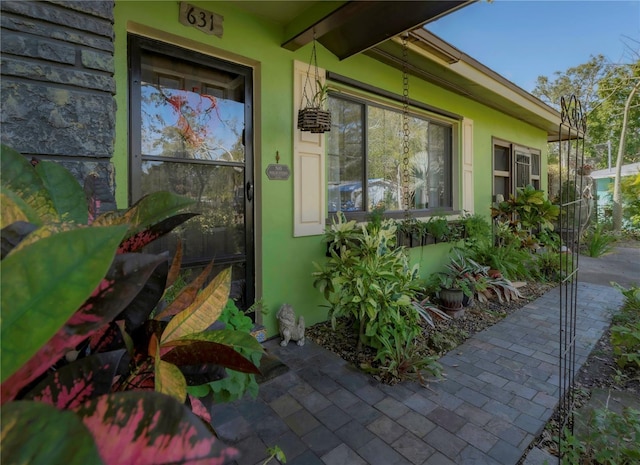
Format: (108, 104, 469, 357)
(35, 161, 88, 224)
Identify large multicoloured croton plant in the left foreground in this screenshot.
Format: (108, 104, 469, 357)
(0, 146, 262, 465)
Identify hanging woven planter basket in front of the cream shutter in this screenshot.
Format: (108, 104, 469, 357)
(298, 37, 331, 134)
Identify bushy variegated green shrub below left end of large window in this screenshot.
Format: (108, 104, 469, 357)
(313, 214, 437, 377)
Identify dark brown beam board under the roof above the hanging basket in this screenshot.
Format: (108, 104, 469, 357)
(282, 0, 476, 60)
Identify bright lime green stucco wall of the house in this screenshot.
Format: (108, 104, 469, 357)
(114, 1, 546, 336)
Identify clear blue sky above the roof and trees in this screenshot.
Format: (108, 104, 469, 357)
(425, 0, 640, 92)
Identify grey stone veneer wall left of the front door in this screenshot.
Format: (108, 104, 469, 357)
(0, 0, 116, 211)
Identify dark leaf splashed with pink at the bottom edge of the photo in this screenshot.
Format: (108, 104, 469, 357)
(74, 392, 238, 465)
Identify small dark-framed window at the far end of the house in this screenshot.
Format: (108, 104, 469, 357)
(493, 139, 540, 199)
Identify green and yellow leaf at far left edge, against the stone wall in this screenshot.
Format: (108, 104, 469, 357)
(0, 144, 59, 224)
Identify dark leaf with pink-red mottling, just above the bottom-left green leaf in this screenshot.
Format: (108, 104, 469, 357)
(23, 349, 125, 410)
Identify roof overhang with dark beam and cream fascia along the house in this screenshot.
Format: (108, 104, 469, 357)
(231, 0, 568, 142)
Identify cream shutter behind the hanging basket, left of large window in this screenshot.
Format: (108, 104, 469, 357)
(293, 61, 326, 237)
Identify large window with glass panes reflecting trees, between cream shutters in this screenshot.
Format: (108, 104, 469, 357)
(327, 94, 453, 217)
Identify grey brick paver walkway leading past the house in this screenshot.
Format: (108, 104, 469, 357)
(213, 283, 622, 465)
